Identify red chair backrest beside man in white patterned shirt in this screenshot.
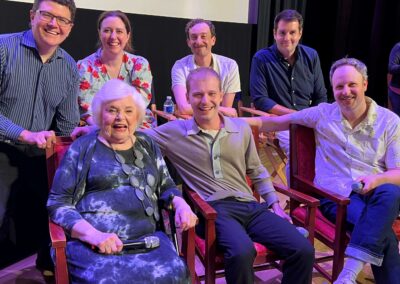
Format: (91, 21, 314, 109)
(290, 124, 315, 188)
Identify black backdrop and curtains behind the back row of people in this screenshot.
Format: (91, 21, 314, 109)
(0, 0, 400, 107)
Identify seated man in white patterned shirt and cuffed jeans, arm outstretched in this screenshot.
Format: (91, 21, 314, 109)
(250, 58, 400, 284)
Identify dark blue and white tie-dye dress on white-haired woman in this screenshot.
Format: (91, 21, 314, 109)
(47, 133, 190, 283)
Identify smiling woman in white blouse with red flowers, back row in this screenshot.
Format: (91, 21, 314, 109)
(78, 11, 156, 128)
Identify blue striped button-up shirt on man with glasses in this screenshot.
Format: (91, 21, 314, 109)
(0, 30, 79, 141)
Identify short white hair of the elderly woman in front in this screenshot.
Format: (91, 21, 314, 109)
(91, 79, 146, 128)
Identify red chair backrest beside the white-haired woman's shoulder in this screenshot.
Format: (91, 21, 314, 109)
(46, 136, 72, 190)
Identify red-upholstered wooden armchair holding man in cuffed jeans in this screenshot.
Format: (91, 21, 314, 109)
(290, 125, 400, 282)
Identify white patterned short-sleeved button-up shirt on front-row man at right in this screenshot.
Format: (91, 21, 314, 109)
(291, 97, 400, 197)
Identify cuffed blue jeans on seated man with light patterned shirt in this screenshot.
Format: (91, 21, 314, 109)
(321, 184, 400, 284)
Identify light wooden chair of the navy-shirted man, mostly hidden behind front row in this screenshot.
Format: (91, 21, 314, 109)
(239, 106, 288, 185)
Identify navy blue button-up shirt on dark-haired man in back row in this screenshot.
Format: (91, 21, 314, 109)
(250, 44, 327, 111)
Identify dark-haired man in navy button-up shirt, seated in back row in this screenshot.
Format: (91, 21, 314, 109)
(250, 10, 327, 165)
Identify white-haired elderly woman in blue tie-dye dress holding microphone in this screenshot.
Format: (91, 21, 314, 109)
(47, 79, 197, 283)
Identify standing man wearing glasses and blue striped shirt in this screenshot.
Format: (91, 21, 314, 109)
(0, 0, 79, 274)
